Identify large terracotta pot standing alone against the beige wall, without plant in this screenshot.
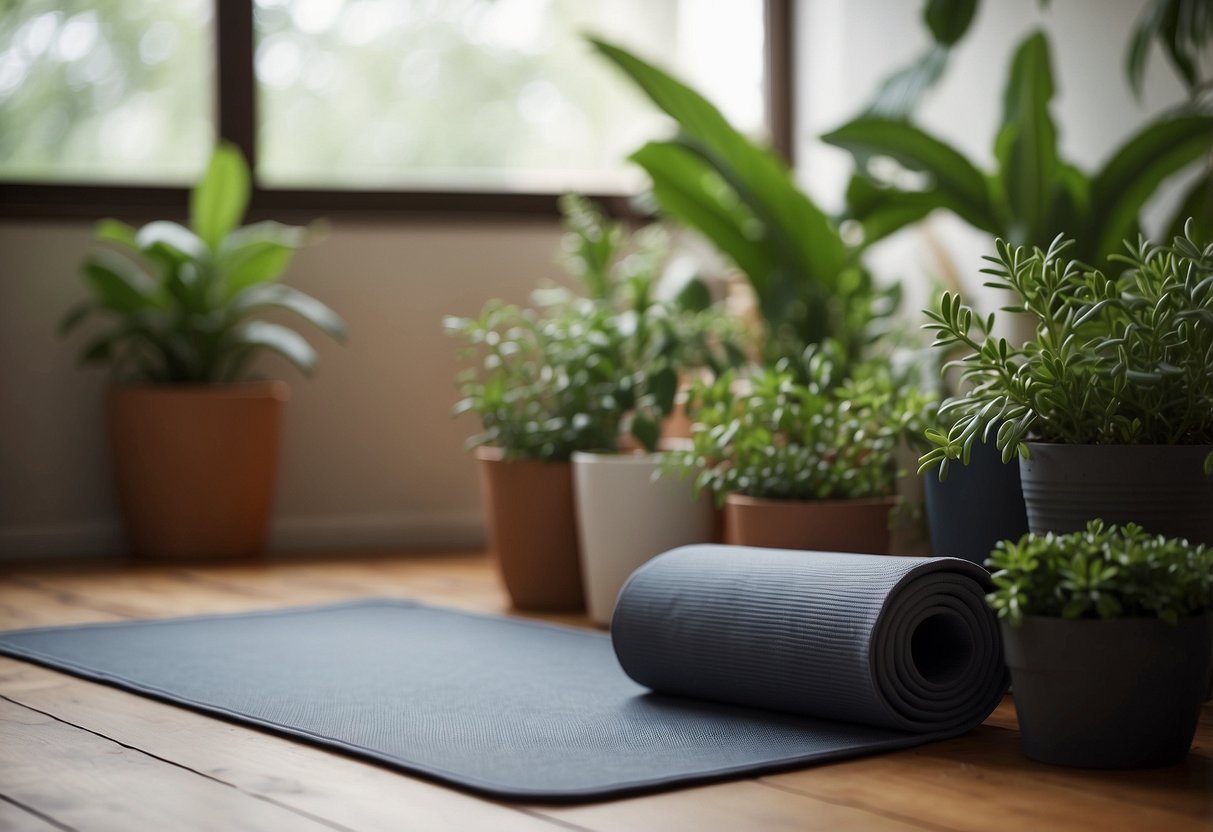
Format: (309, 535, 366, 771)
(106, 381, 289, 558)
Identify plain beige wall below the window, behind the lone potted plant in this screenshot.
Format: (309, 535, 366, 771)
(0, 221, 559, 557)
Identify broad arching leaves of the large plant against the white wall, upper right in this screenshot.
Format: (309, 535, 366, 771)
(822, 32, 1213, 266)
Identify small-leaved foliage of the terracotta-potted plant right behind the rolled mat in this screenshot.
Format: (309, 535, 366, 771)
(666, 347, 924, 503)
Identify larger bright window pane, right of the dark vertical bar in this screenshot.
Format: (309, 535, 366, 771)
(255, 0, 765, 192)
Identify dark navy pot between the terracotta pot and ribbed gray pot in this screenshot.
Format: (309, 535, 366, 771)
(923, 443, 1027, 565)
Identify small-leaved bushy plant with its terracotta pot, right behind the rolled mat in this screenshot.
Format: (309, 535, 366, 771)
(667, 346, 926, 553)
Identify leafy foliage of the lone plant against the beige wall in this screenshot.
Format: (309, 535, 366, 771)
(59, 144, 346, 384)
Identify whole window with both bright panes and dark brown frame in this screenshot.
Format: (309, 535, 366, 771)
(0, 0, 791, 216)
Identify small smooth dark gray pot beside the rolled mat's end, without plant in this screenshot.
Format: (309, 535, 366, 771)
(1002, 614, 1213, 769)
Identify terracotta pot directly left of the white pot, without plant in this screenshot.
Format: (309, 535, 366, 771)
(475, 448, 585, 610)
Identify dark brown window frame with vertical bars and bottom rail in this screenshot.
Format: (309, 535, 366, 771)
(0, 0, 796, 222)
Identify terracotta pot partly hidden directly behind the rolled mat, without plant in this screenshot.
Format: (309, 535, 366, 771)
(724, 494, 896, 554)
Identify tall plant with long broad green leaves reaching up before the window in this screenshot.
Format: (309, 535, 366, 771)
(592, 40, 900, 360)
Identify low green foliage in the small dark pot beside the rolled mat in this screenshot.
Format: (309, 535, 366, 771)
(986, 520, 1213, 627)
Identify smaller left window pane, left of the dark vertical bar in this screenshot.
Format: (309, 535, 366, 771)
(0, 0, 215, 183)
